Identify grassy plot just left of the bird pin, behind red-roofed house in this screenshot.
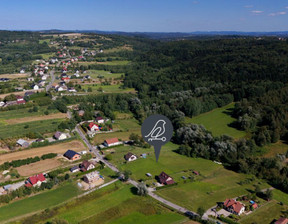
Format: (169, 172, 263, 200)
(93, 119, 141, 144)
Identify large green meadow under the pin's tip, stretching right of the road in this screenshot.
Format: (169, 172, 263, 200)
(105, 143, 269, 211)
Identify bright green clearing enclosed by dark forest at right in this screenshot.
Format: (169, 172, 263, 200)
(186, 103, 246, 138)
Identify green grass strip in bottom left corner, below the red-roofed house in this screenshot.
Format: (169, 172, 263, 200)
(0, 183, 79, 222)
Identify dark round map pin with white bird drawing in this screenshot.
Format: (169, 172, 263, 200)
(141, 114, 173, 162)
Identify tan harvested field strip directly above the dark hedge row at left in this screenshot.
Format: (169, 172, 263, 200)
(0, 140, 86, 164)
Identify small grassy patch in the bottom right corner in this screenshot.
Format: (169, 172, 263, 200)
(239, 201, 288, 224)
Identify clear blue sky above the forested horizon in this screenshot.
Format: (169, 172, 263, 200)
(0, 0, 288, 32)
